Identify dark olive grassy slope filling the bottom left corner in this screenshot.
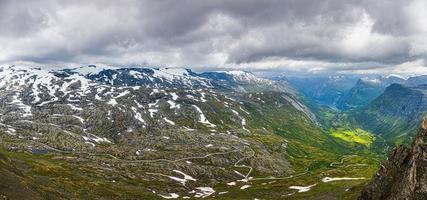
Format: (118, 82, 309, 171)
(0, 148, 166, 199)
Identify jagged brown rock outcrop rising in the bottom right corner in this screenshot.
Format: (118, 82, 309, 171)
(359, 118, 427, 200)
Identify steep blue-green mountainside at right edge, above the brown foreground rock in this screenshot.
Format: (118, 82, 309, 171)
(352, 84, 427, 143)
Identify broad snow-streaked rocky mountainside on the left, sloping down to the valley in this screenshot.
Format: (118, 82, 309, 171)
(0, 66, 360, 199)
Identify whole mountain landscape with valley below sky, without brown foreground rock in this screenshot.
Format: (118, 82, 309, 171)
(0, 65, 425, 199)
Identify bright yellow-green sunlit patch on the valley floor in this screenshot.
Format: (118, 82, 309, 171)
(330, 128, 375, 147)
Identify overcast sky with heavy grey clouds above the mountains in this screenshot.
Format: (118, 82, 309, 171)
(0, 0, 427, 74)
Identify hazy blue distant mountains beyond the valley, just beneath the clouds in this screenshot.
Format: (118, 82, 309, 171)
(288, 74, 427, 110)
